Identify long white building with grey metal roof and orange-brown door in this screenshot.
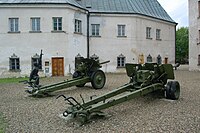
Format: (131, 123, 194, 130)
(0, 0, 177, 77)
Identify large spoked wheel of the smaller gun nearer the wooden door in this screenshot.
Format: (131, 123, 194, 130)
(91, 70, 106, 89)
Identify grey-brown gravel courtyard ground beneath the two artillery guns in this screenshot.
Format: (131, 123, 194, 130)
(0, 69, 200, 133)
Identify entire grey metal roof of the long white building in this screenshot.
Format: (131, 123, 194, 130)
(0, 0, 175, 23)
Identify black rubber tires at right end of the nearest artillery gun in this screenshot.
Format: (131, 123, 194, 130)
(166, 81, 180, 100)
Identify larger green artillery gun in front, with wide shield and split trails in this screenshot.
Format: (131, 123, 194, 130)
(58, 63, 180, 124)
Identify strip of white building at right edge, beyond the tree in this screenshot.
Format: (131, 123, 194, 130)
(188, 0, 200, 71)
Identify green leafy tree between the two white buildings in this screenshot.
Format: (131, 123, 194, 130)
(176, 27, 189, 64)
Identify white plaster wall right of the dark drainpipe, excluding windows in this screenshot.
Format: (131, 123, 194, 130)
(90, 14, 175, 72)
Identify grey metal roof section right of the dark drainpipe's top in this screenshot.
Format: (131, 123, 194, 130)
(77, 0, 175, 23)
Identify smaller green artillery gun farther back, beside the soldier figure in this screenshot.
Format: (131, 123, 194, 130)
(22, 57, 110, 96)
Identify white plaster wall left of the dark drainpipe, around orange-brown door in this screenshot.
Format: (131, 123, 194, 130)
(0, 5, 87, 77)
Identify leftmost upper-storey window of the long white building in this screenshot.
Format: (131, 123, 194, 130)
(9, 18, 19, 32)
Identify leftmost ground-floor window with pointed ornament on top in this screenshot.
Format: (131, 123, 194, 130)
(9, 54, 20, 71)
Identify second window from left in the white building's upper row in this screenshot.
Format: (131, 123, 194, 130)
(30, 17, 41, 32)
